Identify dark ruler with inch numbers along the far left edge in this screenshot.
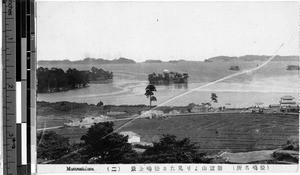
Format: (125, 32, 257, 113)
(2, 1, 17, 175)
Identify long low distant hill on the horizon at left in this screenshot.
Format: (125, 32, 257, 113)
(38, 57, 136, 65)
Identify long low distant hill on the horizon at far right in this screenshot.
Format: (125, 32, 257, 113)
(204, 55, 299, 62)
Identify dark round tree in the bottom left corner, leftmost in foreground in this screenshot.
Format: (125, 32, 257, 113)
(37, 131, 71, 160)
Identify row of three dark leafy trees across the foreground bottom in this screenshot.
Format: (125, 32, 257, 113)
(37, 122, 207, 164)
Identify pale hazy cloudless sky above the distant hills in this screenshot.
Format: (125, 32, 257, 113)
(37, 1, 299, 61)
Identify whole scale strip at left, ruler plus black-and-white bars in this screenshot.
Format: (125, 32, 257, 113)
(2, 0, 36, 175)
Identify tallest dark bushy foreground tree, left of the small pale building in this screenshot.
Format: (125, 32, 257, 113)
(81, 122, 137, 164)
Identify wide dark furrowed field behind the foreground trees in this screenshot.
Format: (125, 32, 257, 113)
(39, 114, 299, 152)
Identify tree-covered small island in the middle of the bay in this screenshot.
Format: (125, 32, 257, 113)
(148, 72, 189, 85)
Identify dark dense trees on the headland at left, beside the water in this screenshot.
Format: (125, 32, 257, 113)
(37, 67, 113, 93)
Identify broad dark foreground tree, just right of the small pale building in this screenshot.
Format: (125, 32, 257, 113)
(139, 134, 205, 163)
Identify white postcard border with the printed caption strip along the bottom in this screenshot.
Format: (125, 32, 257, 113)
(36, 0, 300, 175)
